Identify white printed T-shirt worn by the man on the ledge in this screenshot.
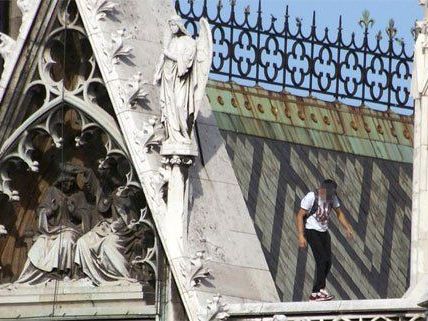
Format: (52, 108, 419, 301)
(300, 192, 340, 232)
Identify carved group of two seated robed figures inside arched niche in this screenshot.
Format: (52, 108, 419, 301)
(9, 158, 157, 286)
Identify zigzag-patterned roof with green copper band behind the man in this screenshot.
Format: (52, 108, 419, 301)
(208, 82, 413, 301)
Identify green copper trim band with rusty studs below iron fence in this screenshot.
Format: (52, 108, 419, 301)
(207, 81, 413, 163)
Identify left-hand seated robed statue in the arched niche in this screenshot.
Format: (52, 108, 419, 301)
(16, 163, 91, 284)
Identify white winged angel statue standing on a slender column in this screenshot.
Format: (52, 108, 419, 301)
(154, 16, 212, 155)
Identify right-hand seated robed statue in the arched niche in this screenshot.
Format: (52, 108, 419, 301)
(75, 162, 138, 285)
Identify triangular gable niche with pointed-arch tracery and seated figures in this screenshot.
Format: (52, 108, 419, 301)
(0, 1, 159, 298)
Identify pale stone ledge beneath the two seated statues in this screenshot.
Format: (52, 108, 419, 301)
(0, 282, 156, 320)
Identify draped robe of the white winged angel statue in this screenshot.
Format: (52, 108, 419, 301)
(160, 35, 196, 144)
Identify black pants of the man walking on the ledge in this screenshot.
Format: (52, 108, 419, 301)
(305, 229, 331, 293)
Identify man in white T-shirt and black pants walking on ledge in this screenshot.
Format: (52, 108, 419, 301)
(296, 179, 354, 301)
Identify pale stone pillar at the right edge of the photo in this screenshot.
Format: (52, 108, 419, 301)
(410, 0, 428, 292)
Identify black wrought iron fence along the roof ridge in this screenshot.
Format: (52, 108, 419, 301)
(175, 0, 415, 113)
